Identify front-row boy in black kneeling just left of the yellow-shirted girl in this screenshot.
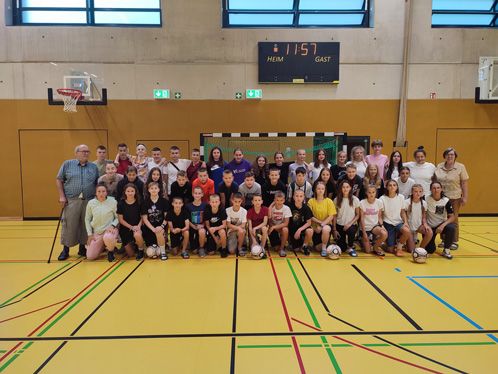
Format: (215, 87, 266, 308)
(289, 190, 313, 256)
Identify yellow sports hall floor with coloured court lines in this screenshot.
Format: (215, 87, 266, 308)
(0, 217, 498, 374)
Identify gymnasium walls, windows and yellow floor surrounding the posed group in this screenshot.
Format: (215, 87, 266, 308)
(0, 0, 498, 374)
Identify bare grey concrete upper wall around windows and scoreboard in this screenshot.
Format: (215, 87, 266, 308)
(0, 0, 498, 100)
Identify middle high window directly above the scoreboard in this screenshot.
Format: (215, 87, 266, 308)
(223, 0, 371, 28)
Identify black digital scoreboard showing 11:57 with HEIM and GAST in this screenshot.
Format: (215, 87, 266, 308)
(258, 42, 340, 84)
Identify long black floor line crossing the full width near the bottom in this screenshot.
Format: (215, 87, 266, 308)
(0, 329, 498, 342)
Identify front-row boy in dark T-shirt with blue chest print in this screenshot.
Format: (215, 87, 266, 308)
(187, 187, 207, 257)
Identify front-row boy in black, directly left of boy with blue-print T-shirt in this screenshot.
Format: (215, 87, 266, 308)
(166, 196, 190, 259)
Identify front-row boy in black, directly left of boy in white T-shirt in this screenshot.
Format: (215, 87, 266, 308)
(204, 194, 228, 257)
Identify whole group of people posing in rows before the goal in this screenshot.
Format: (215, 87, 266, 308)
(56, 139, 469, 262)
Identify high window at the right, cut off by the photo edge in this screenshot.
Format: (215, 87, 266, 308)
(432, 0, 498, 28)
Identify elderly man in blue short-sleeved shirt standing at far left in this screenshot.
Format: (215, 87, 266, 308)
(56, 144, 99, 261)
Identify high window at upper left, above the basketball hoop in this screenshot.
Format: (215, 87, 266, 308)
(13, 0, 162, 27)
